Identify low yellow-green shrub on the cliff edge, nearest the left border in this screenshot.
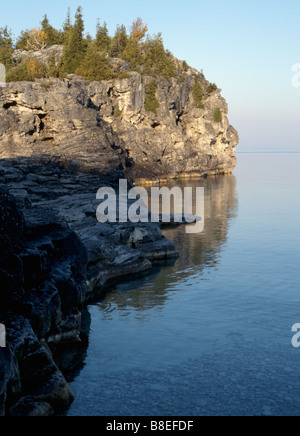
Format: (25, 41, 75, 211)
(6, 58, 47, 82)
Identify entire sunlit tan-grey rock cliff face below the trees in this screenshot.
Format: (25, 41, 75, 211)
(0, 57, 238, 180)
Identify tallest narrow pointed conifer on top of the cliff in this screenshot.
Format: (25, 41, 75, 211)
(61, 7, 87, 73)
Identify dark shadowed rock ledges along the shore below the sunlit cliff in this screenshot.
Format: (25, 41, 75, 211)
(0, 156, 178, 416)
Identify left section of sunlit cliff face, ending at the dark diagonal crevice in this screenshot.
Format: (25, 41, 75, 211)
(0, 79, 124, 176)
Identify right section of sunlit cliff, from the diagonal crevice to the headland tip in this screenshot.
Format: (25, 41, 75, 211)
(88, 69, 238, 180)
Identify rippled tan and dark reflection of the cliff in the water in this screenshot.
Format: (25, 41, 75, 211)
(98, 174, 238, 320)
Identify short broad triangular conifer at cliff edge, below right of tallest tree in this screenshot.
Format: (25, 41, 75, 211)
(76, 44, 115, 82)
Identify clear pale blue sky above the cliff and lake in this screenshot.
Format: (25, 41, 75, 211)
(0, 0, 300, 152)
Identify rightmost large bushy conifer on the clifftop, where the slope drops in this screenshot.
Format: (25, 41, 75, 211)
(144, 34, 177, 80)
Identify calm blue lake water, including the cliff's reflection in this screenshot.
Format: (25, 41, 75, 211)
(63, 154, 300, 416)
